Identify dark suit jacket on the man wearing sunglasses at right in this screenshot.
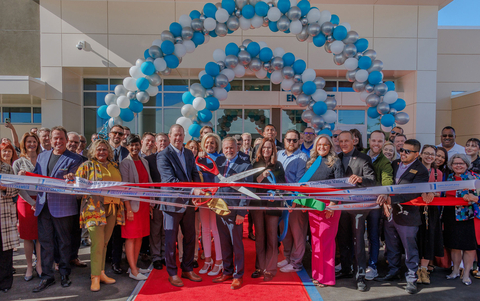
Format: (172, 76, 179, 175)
(391, 160, 430, 226)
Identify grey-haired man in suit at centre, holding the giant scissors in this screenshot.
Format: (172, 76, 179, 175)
(213, 137, 253, 289)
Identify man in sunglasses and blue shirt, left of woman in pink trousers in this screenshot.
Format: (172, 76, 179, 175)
(277, 130, 308, 273)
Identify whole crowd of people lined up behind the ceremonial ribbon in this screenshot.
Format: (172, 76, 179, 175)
(0, 120, 480, 294)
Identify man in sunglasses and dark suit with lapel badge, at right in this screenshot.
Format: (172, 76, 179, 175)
(377, 139, 429, 294)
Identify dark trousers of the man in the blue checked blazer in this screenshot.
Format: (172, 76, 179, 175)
(38, 203, 75, 279)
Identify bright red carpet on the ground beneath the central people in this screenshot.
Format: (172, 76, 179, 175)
(135, 218, 310, 301)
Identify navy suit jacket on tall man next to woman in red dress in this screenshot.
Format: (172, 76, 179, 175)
(157, 145, 201, 213)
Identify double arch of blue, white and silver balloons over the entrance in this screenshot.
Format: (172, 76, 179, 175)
(97, 0, 409, 138)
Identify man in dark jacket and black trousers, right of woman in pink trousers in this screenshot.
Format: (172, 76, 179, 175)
(337, 131, 375, 292)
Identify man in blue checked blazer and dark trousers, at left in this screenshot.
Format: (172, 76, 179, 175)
(33, 126, 83, 293)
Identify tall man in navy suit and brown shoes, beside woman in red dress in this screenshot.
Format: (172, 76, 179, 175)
(157, 124, 202, 287)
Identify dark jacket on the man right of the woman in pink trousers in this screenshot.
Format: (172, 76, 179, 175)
(338, 149, 376, 187)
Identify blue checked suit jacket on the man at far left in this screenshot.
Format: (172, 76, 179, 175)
(33, 150, 83, 218)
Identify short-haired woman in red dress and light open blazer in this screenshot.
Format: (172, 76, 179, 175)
(120, 135, 152, 280)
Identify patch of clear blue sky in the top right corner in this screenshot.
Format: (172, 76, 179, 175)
(438, 0, 480, 26)
